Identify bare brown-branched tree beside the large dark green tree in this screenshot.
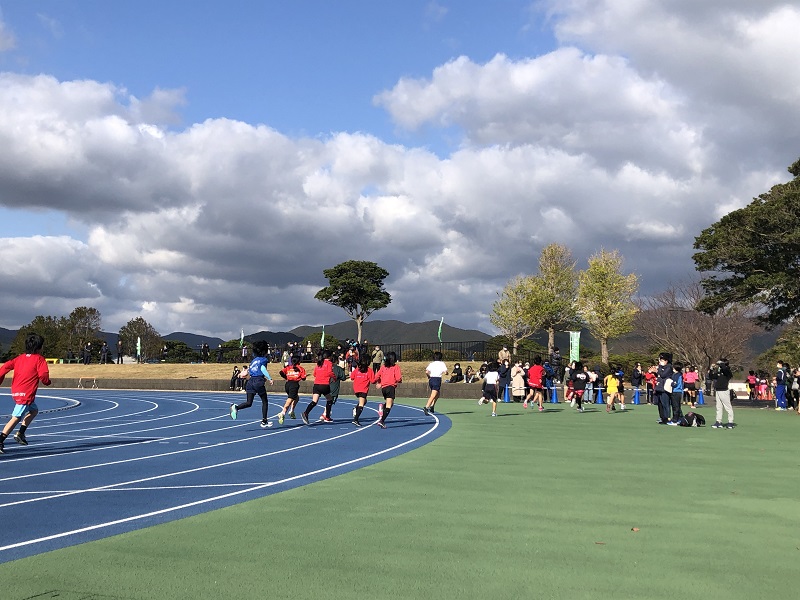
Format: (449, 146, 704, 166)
(636, 281, 760, 372)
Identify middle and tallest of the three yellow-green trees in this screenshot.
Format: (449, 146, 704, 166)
(529, 244, 578, 353)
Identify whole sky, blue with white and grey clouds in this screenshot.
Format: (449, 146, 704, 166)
(0, 0, 800, 337)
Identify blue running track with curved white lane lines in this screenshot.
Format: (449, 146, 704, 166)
(0, 390, 450, 563)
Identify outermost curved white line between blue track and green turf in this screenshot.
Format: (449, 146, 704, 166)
(0, 407, 441, 552)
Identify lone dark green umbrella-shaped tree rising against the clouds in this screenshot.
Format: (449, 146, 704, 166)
(314, 260, 392, 342)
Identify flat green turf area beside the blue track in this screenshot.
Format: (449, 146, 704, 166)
(0, 400, 800, 600)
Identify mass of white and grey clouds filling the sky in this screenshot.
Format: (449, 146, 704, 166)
(0, 0, 800, 337)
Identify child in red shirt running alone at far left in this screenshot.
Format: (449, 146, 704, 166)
(0, 333, 50, 454)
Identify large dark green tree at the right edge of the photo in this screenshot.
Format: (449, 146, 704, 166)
(693, 160, 800, 327)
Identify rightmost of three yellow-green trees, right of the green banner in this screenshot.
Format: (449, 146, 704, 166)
(577, 249, 639, 363)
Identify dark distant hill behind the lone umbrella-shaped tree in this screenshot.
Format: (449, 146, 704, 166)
(290, 320, 492, 344)
